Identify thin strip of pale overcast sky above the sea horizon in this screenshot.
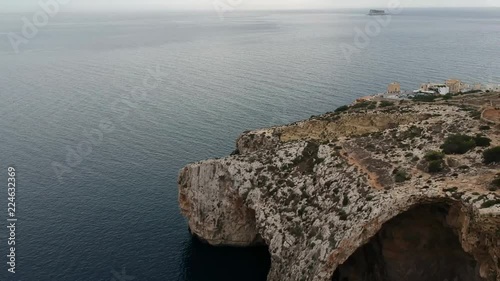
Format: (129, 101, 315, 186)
(0, 0, 500, 12)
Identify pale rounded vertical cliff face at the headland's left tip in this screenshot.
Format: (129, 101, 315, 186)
(179, 161, 260, 246)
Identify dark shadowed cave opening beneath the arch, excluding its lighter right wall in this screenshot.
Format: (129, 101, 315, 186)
(332, 204, 484, 281)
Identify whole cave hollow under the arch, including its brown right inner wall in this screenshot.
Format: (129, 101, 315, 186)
(331, 201, 500, 281)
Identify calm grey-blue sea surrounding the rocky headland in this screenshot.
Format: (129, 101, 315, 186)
(0, 9, 500, 281)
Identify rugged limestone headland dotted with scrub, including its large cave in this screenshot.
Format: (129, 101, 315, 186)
(179, 94, 500, 281)
